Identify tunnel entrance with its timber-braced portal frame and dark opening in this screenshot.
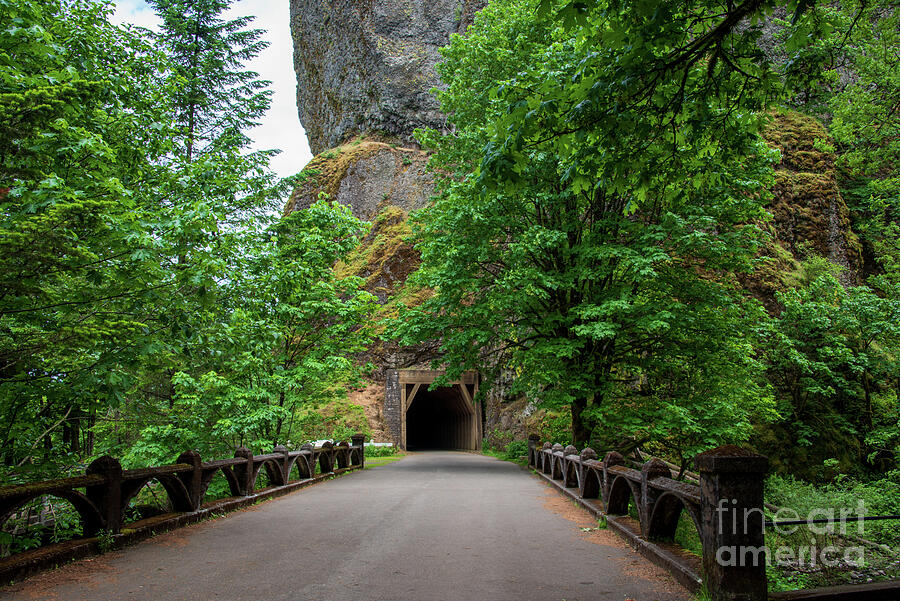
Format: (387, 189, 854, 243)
(399, 370, 481, 451)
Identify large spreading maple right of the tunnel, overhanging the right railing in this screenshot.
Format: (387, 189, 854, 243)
(398, 0, 777, 450)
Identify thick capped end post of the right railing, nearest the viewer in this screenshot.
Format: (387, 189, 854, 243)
(694, 446, 769, 601)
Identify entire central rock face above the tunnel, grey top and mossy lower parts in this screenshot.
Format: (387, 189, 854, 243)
(284, 0, 487, 440)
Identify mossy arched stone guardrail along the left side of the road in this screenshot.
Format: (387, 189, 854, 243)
(0, 434, 365, 579)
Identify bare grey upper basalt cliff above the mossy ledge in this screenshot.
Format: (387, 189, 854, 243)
(291, 0, 487, 154)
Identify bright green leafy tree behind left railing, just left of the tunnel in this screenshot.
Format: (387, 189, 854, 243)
(125, 201, 375, 465)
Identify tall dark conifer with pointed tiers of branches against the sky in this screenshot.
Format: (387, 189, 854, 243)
(123, 0, 288, 422)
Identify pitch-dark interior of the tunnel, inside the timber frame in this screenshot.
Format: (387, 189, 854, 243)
(406, 386, 475, 451)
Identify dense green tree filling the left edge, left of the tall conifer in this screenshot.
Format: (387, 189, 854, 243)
(0, 0, 181, 465)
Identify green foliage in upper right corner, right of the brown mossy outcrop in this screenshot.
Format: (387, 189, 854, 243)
(783, 0, 900, 288)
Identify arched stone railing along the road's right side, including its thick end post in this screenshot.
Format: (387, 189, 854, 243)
(528, 435, 768, 601)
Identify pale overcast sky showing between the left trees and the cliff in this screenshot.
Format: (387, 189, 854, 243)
(113, 0, 312, 177)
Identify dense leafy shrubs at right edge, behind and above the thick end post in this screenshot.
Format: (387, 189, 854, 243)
(768, 274, 900, 478)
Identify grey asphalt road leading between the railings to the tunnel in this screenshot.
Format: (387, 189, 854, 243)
(0, 452, 690, 601)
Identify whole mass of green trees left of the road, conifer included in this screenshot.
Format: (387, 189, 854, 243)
(0, 0, 373, 481)
